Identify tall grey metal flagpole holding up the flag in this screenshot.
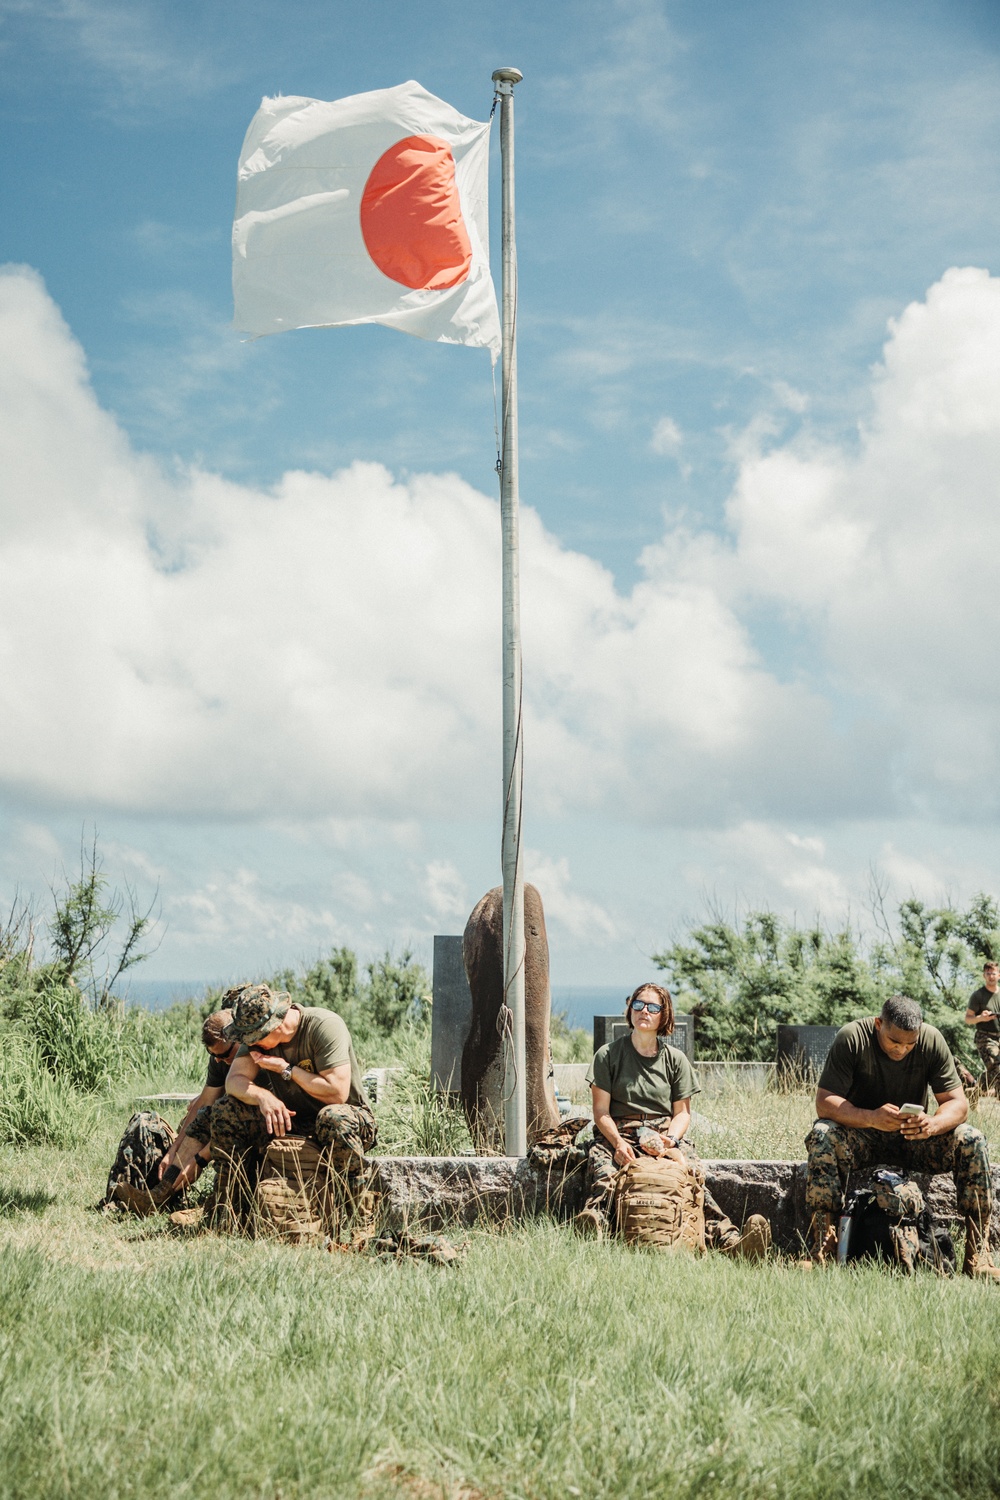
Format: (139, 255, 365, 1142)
(493, 68, 528, 1157)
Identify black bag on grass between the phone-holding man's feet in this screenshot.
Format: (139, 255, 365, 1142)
(838, 1170, 955, 1277)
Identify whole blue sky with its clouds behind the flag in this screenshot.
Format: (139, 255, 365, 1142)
(0, 0, 1000, 987)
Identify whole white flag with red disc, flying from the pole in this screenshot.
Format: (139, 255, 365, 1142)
(232, 81, 501, 359)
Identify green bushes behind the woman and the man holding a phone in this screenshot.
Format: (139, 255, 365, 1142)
(654, 891, 1000, 1061)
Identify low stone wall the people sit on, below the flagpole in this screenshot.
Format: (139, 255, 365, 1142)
(372, 1157, 1000, 1254)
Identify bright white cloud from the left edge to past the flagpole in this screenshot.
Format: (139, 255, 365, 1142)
(0, 259, 869, 819)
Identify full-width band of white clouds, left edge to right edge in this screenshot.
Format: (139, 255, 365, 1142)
(0, 267, 1000, 840)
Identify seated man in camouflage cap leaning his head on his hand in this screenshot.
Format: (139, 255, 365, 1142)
(210, 984, 376, 1218)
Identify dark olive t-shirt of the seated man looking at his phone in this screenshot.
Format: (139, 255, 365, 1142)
(819, 1016, 961, 1110)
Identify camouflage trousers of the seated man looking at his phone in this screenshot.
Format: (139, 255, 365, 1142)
(805, 1121, 993, 1224)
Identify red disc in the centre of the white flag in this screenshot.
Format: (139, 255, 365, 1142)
(361, 135, 472, 291)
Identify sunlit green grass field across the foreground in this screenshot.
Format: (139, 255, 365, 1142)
(0, 1101, 1000, 1500)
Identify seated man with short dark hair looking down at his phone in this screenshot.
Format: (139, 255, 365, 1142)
(805, 995, 1000, 1281)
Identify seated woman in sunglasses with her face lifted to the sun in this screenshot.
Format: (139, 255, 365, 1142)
(574, 984, 771, 1260)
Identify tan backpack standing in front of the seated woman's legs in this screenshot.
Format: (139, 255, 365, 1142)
(615, 1154, 705, 1253)
